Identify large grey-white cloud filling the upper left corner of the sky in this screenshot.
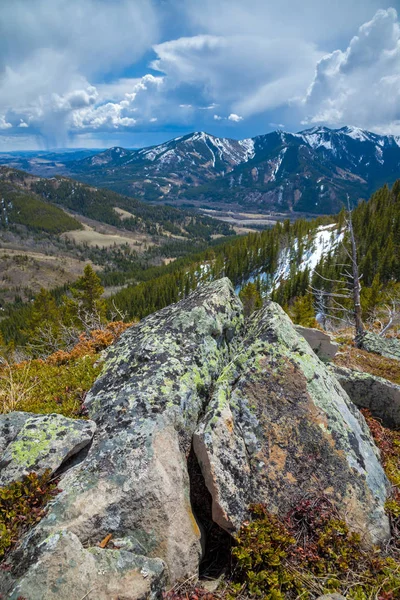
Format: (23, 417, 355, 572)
(0, 0, 159, 145)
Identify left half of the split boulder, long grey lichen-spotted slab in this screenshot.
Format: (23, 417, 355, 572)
(0, 279, 243, 598)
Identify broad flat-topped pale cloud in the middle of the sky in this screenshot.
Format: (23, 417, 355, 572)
(152, 35, 322, 117)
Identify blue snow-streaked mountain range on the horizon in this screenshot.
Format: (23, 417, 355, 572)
(69, 127, 400, 213)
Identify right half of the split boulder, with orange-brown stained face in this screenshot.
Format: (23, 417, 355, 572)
(194, 303, 389, 542)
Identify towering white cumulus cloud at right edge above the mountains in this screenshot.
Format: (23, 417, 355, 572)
(303, 8, 400, 132)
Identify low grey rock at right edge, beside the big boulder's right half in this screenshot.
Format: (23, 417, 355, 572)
(332, 366, 400, 429)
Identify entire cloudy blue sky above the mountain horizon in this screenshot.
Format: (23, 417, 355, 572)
(0, 0, 400, 151)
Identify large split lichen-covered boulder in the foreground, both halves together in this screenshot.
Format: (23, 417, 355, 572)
(0, 279, 389, 600)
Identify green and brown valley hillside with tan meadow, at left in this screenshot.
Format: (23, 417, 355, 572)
(0, 167, 235, 308)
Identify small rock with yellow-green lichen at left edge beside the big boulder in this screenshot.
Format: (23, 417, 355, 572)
(0, 412, 96, 486)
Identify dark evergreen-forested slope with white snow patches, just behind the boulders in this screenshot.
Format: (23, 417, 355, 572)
(0, 181, 400, 343)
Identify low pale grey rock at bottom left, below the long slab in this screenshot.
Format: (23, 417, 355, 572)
(7, 531, 167, 600)
